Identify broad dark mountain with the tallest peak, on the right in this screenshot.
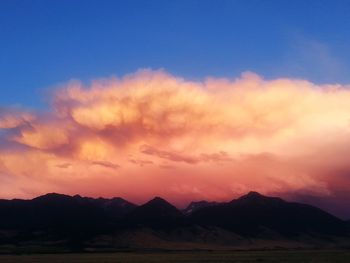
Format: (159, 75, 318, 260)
(190, 192, 346, 237)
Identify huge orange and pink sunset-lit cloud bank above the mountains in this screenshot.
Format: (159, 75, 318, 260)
(0, 70, 350, 216)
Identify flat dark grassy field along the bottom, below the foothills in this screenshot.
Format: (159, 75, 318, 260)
(0, 250, 350, 263)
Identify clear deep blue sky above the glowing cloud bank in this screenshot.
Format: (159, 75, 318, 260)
(0, 0, 350, 108)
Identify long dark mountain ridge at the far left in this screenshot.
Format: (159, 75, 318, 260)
(0, 193, 136, 229)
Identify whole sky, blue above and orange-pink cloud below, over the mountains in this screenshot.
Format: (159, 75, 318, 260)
(0, 0, 350, 218)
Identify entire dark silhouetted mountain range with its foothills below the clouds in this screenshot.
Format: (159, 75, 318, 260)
(0, 192, 350, 253)
